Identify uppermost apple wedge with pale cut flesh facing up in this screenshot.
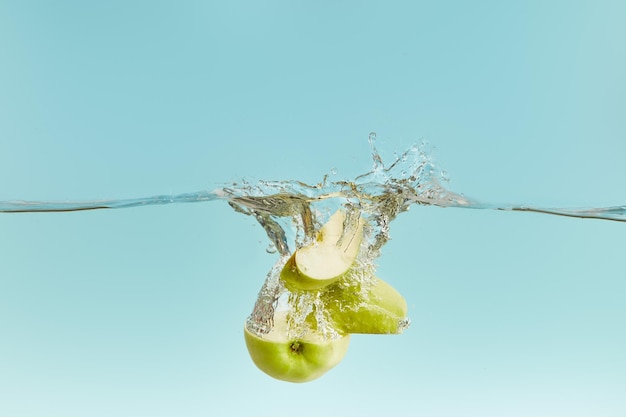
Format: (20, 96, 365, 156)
(280, 210, 364, 290)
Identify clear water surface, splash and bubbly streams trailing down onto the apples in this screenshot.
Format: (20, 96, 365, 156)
(0, 133, 626, 364)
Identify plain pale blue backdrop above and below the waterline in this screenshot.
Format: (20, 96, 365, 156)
(0, 0, 626, 417)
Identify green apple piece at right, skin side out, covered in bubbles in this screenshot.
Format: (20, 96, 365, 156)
(322, 277, 409, 334)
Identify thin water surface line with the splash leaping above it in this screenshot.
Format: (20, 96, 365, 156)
(0, 136, 626, 224)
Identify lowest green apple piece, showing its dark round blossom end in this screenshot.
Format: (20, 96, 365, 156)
(244, 327, 350, 382)
